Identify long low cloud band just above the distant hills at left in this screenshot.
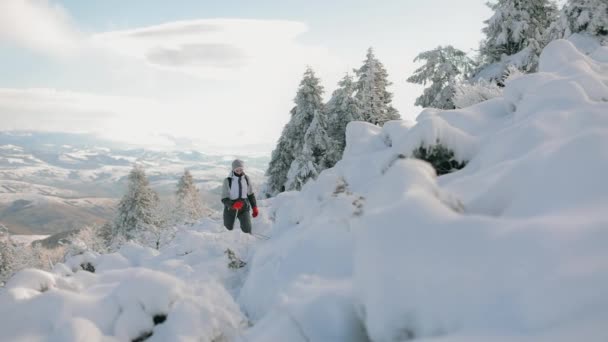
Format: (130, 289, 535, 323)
(0, 88, 280, 153)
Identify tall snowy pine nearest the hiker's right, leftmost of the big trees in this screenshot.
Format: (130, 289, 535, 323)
(266, 67, 323, 194)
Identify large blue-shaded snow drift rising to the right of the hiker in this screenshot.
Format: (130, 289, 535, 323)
(239, 40, 608, 341)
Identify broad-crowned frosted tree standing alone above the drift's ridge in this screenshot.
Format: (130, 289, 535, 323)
(407, 45, 474, 109)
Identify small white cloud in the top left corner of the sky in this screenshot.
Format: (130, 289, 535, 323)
(0, 0, 80, 57)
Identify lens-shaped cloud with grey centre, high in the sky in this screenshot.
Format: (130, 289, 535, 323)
(91, 19, 326, 79)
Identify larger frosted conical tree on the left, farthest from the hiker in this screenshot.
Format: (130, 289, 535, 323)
(112, 165, 160, 240)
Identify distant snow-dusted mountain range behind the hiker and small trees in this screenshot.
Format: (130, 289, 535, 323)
(0, 132, 269, 234)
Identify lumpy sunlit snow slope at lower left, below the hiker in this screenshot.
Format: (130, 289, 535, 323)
(0, 221, 255, 342)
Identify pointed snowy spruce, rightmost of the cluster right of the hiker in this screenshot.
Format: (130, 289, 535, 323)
(355, 48, 399, 126)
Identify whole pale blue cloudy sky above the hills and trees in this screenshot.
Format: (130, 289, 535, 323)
(0, 0, 491, 153)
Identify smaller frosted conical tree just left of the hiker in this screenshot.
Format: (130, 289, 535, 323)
(175, 170, 205, 224)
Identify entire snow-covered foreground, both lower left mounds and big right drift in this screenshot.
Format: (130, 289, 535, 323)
(0, 40, 608, 342)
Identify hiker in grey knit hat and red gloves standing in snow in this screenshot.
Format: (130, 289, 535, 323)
(222, 159, 258, 234)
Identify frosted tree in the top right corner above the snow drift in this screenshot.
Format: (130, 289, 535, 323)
(551, 0, 608, 41)
